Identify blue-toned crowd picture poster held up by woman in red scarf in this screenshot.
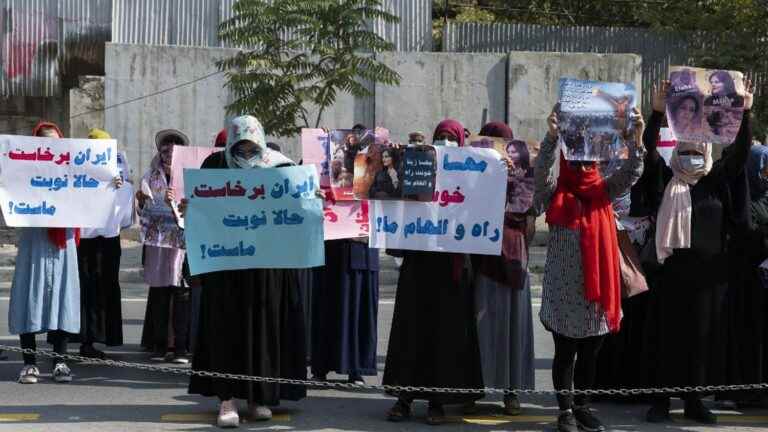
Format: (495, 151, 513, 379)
(558, 78, 637, 161)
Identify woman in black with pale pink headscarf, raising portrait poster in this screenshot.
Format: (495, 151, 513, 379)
(645, 77, 753, 424)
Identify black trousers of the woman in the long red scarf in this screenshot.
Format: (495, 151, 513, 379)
(552, 333, 605, 410)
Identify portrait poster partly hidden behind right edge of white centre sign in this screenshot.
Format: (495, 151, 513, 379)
(469, 135, 538, 213)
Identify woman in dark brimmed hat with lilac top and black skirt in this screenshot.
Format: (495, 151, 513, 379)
(136, 129, 191, 364)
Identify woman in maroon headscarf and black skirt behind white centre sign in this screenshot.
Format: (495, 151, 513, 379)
(383, 120, 483, 425)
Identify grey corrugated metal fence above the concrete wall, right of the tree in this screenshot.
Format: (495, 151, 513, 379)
(443, 23, 688, 111)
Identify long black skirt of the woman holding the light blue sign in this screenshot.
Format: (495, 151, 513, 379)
(189, 269, 307, 406)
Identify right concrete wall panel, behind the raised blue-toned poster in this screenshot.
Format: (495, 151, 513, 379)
(507, 52, 643, 141)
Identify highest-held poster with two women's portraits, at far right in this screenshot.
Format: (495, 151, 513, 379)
(667, 66, 744, 145)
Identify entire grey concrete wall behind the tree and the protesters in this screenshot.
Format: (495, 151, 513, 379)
(102, 44, 641, 179)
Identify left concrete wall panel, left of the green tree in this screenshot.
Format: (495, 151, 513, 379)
(105, 44, 236, 182)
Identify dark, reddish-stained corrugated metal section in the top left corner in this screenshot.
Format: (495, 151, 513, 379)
(0, 0, 112, 96)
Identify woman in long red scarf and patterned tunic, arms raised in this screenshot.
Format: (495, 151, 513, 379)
(534, 107, 645, 432)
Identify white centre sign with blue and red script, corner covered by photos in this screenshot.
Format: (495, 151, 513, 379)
(370, 147, 507, 255)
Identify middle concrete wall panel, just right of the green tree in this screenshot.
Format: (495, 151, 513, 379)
(376, 53, 507, 141)
